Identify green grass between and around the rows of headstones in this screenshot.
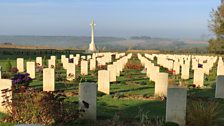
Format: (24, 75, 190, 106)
(0, 53, 222, 125)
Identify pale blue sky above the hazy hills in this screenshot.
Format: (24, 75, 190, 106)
(0, 0, 220, 38)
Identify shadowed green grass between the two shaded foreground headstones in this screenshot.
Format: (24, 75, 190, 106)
(97, 99, 166, 121)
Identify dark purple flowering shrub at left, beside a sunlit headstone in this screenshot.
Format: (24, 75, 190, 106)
(12, 73, 32, 87)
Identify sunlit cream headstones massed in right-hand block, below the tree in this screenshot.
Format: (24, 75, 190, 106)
(145, 54, 217, 87)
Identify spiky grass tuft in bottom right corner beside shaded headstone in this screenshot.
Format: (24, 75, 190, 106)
(187, 101, 223, 126)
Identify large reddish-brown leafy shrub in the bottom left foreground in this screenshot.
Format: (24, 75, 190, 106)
(2, 89, 80, 125)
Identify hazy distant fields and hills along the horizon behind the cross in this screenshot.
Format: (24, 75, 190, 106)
(0, 36, 208, 51)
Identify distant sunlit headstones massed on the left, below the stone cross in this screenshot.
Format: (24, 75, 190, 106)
(17, 53, 124, 80)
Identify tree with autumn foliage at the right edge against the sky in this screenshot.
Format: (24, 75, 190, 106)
(208, 4, 224, 53)
